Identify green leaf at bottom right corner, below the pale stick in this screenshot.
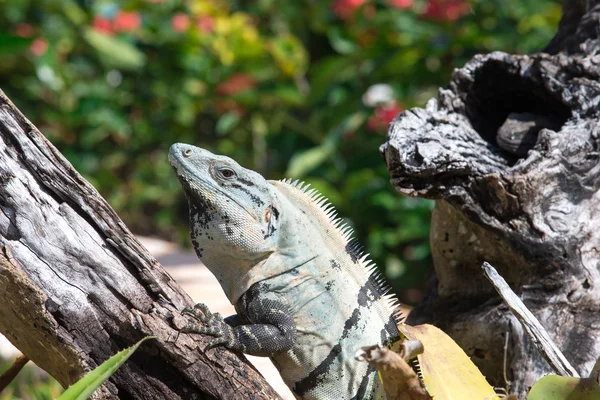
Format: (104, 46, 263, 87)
(527, 375, 600, 400)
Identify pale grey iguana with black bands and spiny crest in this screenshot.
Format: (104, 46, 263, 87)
(169, 143, 401, 400)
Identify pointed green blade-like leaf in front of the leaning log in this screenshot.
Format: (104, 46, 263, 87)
(58, 336, 155, 400)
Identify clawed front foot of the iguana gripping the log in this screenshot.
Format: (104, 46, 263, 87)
(181, 303, 234, 348)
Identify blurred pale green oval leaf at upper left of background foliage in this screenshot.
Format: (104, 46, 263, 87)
(83, 29, 146, 70)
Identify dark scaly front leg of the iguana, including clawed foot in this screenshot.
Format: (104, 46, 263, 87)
(182, 288, 296, 357)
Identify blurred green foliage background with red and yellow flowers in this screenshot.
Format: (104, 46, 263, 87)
(0, 0, 561, 399)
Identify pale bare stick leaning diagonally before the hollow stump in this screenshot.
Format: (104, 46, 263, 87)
(481, 262, 579, 377)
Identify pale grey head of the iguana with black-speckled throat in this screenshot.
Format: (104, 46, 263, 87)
(169, 143, 279, 264)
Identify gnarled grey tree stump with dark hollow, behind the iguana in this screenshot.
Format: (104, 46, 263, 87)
(381, 0, 600, 396)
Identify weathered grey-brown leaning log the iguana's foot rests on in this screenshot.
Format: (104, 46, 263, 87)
(0, 91, 278, 400)
